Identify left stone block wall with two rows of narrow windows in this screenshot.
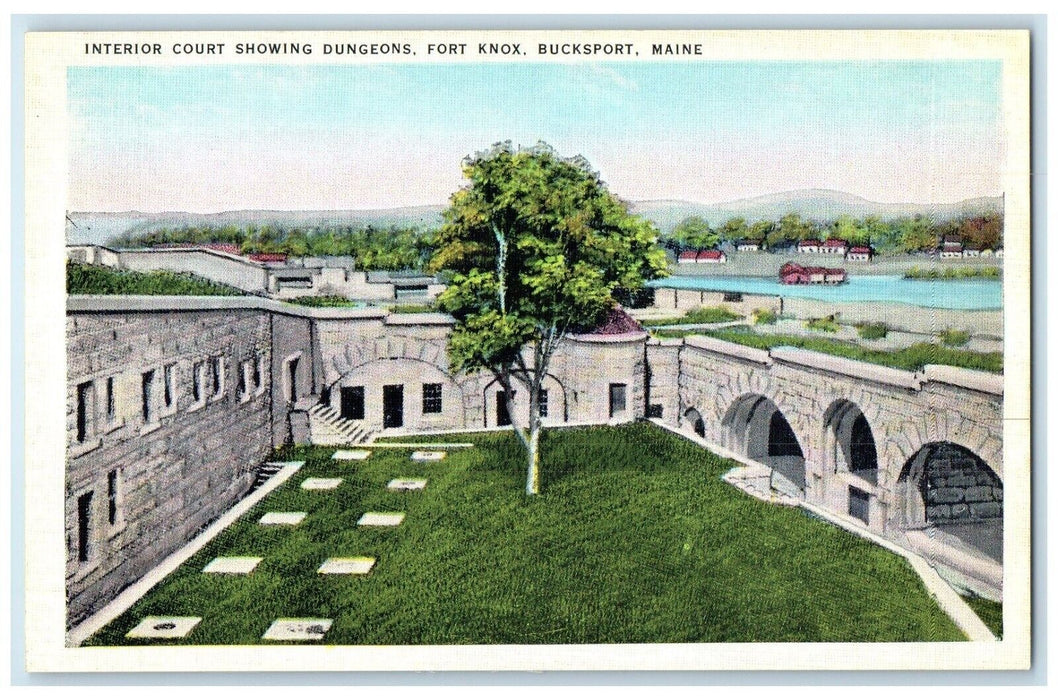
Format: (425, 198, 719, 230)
(66, 310, 272, 624)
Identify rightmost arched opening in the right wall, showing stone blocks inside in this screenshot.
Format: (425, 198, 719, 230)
(896, 442, 1003, 561)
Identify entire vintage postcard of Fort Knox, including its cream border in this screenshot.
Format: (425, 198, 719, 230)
(24, 30, 1033, 671)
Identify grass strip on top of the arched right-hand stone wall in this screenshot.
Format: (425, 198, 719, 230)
(655, 328, 1003, 372)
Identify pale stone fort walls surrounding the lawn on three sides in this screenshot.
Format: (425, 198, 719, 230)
(66, 296, 1003, 626)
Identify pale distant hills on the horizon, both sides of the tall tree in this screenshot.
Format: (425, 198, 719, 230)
(67, 189, 1003, 244)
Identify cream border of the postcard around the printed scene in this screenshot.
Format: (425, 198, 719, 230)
(24, 30, 1032, 671)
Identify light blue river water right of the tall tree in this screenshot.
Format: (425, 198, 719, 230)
(649, 275, 1003, 311)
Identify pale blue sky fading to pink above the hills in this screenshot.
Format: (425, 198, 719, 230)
(67, 60, 1005, 213)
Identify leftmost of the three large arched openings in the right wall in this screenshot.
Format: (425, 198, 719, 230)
(722, 394, 805, 497)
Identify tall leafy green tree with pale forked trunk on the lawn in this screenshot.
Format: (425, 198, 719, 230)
(430, 142, 667, 494)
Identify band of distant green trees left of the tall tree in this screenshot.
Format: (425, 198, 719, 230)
(112, 224, 436, 270)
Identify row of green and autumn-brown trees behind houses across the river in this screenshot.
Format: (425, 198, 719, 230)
(661, 211, 1003, 255)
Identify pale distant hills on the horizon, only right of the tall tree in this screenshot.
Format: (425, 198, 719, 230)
(633, 189, 1003, 232)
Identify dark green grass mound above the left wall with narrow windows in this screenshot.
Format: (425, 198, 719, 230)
(67, 262, 245, 296)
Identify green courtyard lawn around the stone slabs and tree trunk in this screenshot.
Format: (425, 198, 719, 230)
(88, 423, 964, 645)
